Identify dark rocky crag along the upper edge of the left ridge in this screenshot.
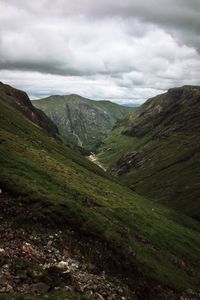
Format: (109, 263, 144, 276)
(0, 82, 59, 137)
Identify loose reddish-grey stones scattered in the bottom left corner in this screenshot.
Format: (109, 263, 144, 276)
(0, 197, 134, 300)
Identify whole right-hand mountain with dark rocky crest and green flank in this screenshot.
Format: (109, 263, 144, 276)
(98, 86, 200, 218)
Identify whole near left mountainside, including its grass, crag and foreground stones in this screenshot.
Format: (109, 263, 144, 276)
(0, 84, 200, 300)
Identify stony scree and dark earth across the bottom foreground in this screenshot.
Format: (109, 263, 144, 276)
(0, 194, 200, 300)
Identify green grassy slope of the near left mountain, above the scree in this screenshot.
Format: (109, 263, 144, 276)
(0, 84, 200, 300)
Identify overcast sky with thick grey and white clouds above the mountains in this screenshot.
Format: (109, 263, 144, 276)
(0, 0, 200, 104)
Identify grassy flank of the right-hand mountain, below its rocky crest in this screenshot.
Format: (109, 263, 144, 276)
(97, 99, 200, 219)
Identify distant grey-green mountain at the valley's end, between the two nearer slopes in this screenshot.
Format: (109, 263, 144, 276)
(32, 95, 129, 152)
